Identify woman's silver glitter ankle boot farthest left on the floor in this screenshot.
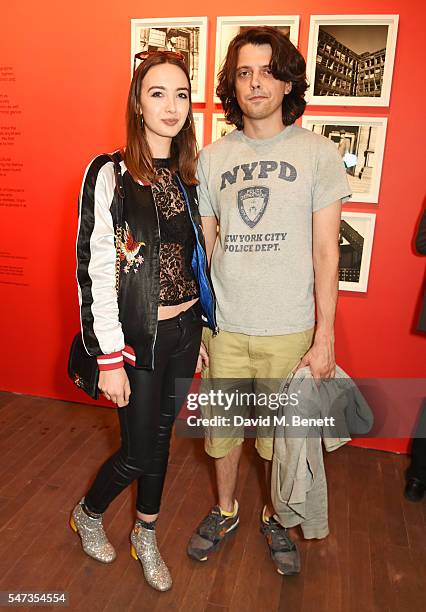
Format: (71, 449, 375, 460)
(70, 498, 117, 563)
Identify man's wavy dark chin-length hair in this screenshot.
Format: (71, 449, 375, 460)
(216, 26, 308, 130)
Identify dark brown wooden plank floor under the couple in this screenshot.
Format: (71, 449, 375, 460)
(0, 393, 426, 612)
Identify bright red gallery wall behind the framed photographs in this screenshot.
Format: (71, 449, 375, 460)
(0, 0, 426, 452)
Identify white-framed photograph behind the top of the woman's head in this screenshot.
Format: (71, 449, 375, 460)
(131, 17, 207, 102)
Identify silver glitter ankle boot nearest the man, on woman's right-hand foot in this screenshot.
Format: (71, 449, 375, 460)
(130, 521, 172, 591)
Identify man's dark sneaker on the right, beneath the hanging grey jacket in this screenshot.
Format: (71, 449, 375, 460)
(260, 516, 300, 576)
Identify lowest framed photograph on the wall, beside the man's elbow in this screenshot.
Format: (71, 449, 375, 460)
(339, 211, 376, 293)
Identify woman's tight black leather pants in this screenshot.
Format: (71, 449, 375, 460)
(85, 303, 202, 514)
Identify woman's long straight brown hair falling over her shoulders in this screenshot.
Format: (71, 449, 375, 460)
(124, 51, 198, 185)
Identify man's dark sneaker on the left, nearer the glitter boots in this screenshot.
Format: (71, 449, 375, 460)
(186, 500, 240, 561)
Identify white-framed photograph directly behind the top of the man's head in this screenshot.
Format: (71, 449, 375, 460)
(213, 15, 299, 104)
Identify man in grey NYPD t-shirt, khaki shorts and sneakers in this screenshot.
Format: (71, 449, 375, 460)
(188, 27, 350, 574)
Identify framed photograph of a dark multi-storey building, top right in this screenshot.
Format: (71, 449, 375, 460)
(307, 15, 398, 106)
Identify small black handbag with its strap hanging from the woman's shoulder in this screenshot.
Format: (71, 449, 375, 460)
(68, 153, 124, 400)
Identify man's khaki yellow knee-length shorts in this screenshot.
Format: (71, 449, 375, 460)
(200, 328, 314, 460)
